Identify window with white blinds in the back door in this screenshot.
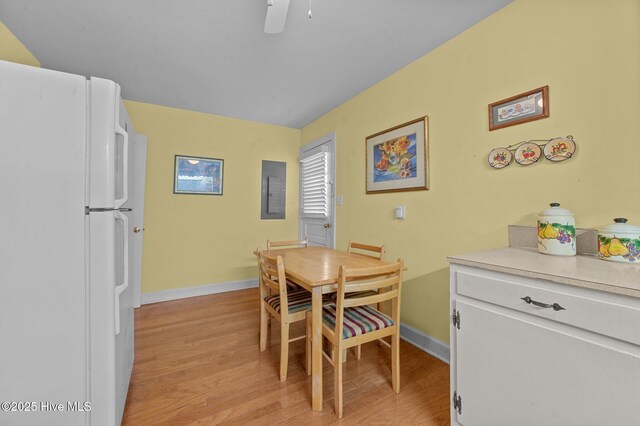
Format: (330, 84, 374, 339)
(300, 152, 329, 219)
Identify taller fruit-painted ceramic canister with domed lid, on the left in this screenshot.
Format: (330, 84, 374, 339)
(538, 203, 576, 256)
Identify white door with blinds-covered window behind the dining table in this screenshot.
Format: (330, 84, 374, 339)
(298, 132, 336, 248)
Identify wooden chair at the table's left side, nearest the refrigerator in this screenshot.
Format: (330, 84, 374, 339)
(258, 251, 311, 381)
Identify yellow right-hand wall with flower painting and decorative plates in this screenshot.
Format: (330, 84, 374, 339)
(302, 0, 640, 341)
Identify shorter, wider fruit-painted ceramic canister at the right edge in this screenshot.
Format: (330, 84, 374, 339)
(598, 217, 640, 263)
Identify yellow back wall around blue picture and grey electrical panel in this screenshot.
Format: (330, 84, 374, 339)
(125, 101, 300, 293)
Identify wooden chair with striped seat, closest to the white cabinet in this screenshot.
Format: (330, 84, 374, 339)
(306, 259, 403, 418)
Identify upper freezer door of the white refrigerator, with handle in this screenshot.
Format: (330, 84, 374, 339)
(89, 77, 130, 209)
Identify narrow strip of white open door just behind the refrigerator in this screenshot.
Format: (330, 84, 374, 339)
(129, 133, 147, 308)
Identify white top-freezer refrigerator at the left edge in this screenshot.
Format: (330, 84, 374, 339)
(0, 61, 138, 426)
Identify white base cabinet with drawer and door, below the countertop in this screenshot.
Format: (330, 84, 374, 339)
(451, 264, 640, 426)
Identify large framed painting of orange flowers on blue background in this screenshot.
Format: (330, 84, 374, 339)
(365, 116, 429, 194)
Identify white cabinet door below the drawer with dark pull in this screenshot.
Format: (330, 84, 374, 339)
(453, 300, 640, 426)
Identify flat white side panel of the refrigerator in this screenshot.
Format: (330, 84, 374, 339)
(0, 61, 89, 425)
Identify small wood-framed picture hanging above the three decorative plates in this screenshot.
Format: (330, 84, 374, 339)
(489, 86, 549, 130)
